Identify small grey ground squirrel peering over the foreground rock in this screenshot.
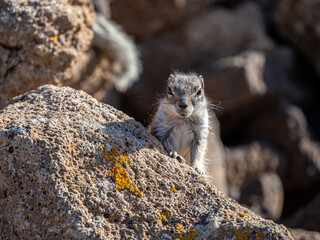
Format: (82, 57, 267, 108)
(149, 72, 209, 174)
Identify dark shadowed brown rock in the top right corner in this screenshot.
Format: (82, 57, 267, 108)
(274, 0, 320, 74)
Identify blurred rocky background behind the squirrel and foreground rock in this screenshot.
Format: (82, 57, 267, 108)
(0, 0, 320, 239)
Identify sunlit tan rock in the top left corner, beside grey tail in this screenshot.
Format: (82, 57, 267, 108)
(0, 0, 94, 108)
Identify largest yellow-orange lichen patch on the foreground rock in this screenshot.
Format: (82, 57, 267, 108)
(101, 147, 143, 197)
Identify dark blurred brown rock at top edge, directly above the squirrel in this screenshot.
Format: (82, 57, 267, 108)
(110, 0, 214, 39)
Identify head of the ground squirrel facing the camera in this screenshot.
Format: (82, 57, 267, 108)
(165, 72, 205, 117)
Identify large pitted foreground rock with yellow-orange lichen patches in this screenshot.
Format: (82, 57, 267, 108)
(0, 85, 292, 239)
